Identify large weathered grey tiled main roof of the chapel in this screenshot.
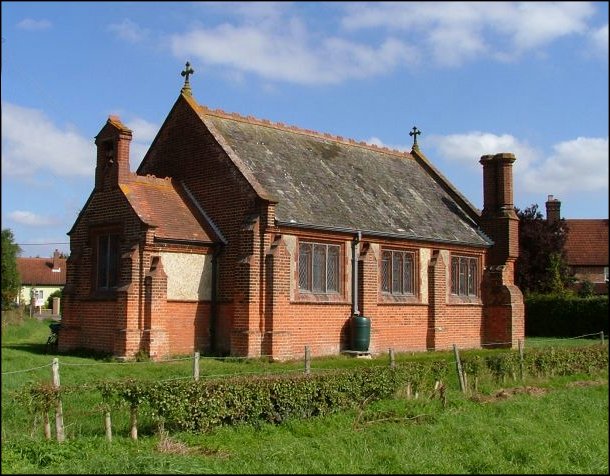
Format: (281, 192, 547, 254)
(198, 107, 490, 246)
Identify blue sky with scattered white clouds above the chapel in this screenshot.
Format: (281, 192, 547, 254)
(2, 1, 608, 256)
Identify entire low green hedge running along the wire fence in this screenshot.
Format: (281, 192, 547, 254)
(16, 345, 608, 432)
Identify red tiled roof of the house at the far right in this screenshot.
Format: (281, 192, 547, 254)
(565, 219, 608, 266)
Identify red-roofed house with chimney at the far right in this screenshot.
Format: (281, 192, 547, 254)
(546, 195, 609, 294)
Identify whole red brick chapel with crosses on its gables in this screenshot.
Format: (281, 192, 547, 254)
(59, 63, 524, 360)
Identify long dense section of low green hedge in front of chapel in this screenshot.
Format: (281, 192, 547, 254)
(102, 361, 449, 432)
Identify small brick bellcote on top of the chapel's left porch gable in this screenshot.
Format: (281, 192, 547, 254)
(95, 116, 132, 189)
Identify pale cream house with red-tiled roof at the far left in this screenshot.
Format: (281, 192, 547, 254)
(17, 250, 66, 306)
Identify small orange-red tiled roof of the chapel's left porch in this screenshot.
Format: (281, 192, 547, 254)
(120, 175, 215, 243)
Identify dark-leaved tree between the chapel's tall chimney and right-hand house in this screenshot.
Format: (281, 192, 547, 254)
(515, 204, 571, 294)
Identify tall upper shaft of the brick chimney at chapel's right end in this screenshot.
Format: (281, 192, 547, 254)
(479, 153, 519, 266)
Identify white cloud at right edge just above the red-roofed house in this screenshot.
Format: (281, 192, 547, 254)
(523, 137, 608, 193)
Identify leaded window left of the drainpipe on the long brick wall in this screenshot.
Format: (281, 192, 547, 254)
(299, 242, 340, 294)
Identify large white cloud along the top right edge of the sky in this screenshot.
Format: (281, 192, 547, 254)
(342, 2, 594, 66)
